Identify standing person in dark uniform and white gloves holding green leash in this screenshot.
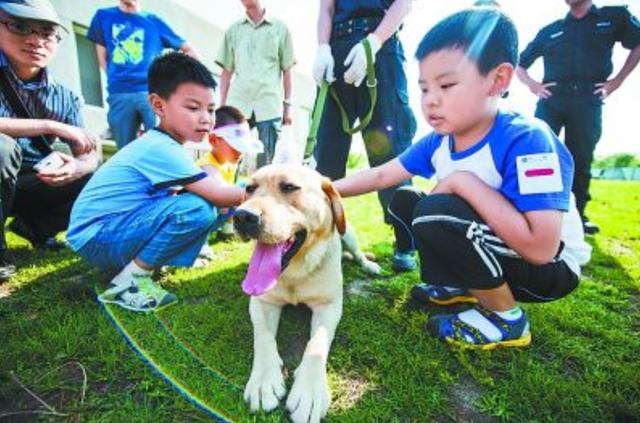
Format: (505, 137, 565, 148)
(313, 0, 416, 271)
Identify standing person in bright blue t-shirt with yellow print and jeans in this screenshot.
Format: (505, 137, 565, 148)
(87, 0, 197, 149)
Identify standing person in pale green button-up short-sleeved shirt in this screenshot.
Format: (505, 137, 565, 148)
(216, 0, 296, 167)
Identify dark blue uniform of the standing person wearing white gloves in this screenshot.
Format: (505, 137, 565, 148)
(314, 0, 416, 221)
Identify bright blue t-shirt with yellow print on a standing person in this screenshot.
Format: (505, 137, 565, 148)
(87, 7, 185, 94)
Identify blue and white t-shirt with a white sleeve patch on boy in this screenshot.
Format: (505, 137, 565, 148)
(400, 112, 573, 212)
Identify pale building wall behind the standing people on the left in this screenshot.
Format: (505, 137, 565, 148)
(50, 0, 315, 144)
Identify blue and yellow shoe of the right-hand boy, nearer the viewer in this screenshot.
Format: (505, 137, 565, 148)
(426, 305, 531, 350)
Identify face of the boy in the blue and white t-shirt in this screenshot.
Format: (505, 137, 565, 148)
(418, 49, 508, 134)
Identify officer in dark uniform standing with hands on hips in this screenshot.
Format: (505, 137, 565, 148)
(517, 0, 640, 234)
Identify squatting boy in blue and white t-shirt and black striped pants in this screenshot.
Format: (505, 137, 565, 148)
(335, 8, 590, 349)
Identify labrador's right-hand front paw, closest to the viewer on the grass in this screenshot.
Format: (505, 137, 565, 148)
(287, 362, 331, 423)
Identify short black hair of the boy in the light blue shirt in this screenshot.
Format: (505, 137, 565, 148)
(149, 51, 217, 99)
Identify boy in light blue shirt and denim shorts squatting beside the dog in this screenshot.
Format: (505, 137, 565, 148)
(67, 53, 244, 311)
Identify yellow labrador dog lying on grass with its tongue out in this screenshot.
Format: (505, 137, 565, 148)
(234, 165, 380, 422)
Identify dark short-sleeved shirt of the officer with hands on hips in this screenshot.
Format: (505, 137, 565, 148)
(520, 6, 640, 83)
